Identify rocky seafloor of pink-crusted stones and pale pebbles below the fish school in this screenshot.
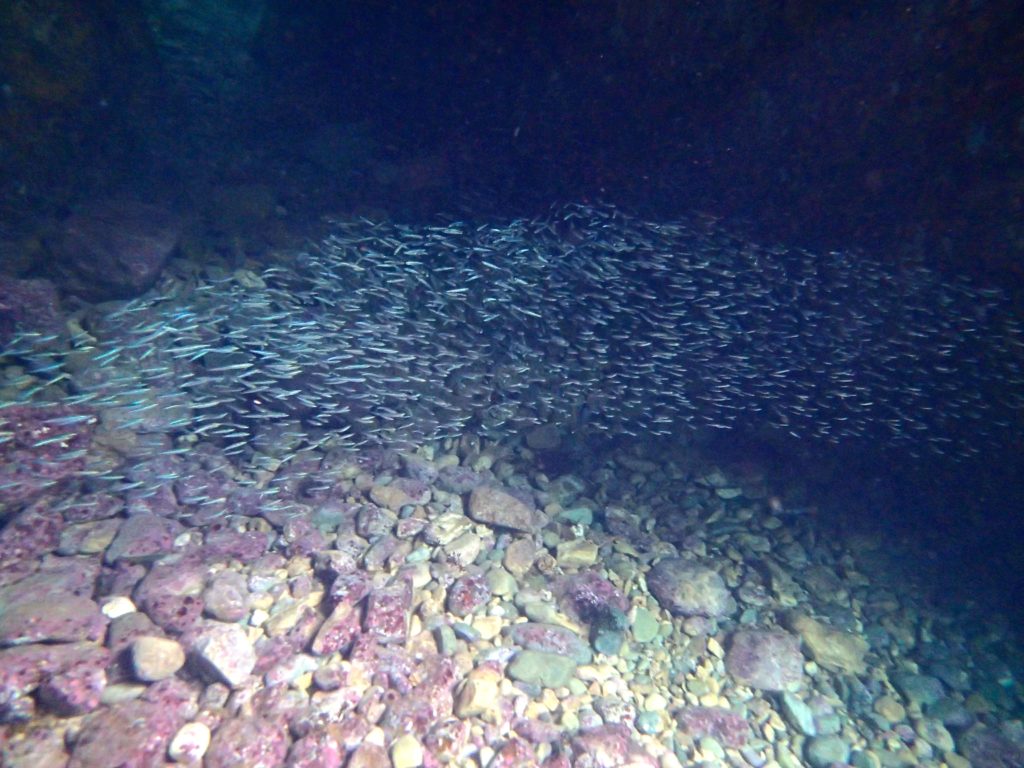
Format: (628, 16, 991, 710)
(0, 207, 1024, 768)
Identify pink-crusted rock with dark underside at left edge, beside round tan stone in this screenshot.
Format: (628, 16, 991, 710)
(0, 643, 111, 720)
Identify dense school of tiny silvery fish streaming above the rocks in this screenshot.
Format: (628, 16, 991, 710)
(0, 205, 1024, 475)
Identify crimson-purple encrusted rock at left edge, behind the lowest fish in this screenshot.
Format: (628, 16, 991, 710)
(0, 406, 96, 514)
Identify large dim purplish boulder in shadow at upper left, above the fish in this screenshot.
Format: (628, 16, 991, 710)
(56, 200, 179, 301)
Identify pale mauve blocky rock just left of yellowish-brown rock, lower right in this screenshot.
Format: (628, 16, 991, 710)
(725, 630, 804, 691)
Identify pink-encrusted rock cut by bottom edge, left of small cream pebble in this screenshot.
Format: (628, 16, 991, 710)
(68, 701, 184, 768)
